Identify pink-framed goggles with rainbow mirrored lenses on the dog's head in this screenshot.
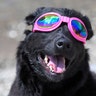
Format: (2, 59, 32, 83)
(33, 12, 88, 43)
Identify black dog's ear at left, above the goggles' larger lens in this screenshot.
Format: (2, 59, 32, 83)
(25, 7, 45, 25)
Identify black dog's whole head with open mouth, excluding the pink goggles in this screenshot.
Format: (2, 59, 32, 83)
(20, 8, 93, 82)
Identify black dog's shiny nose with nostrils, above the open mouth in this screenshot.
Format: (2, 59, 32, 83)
(56, 38, 72, 51)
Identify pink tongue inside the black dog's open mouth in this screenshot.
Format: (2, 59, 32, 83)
(48, 56, 65, 73)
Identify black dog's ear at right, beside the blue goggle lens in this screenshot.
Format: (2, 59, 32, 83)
(84, 16, 93, 40)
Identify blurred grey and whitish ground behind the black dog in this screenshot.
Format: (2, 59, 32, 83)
(0, 0, 96, 96)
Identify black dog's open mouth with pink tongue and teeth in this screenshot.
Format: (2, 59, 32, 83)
(38, 54, 69, 73)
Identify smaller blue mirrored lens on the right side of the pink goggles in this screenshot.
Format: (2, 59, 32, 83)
(71, 20, 87, 38)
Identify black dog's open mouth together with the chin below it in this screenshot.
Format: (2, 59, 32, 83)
(38, 53, 70, 82)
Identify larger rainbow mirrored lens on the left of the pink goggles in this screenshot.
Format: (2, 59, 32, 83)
(37, 14, 59, 27)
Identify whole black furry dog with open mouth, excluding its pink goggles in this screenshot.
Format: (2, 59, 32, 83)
(9, 7, 96, 96)
